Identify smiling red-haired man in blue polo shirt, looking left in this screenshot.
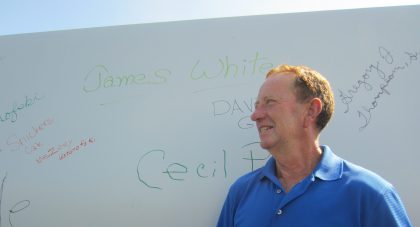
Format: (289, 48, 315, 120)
(217, 65, 411, 227)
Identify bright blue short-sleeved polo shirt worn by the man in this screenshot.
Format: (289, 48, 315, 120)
(217, 146, 411, 227)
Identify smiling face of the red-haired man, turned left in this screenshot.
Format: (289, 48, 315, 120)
(251, 73, 306, 151)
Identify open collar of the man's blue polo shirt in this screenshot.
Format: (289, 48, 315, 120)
(260, 145, 343, 182)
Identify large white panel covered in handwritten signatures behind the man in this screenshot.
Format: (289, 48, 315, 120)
(0, 3, 420, 227)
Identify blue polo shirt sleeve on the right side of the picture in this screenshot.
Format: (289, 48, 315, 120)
(364, 187, 412, 227)
